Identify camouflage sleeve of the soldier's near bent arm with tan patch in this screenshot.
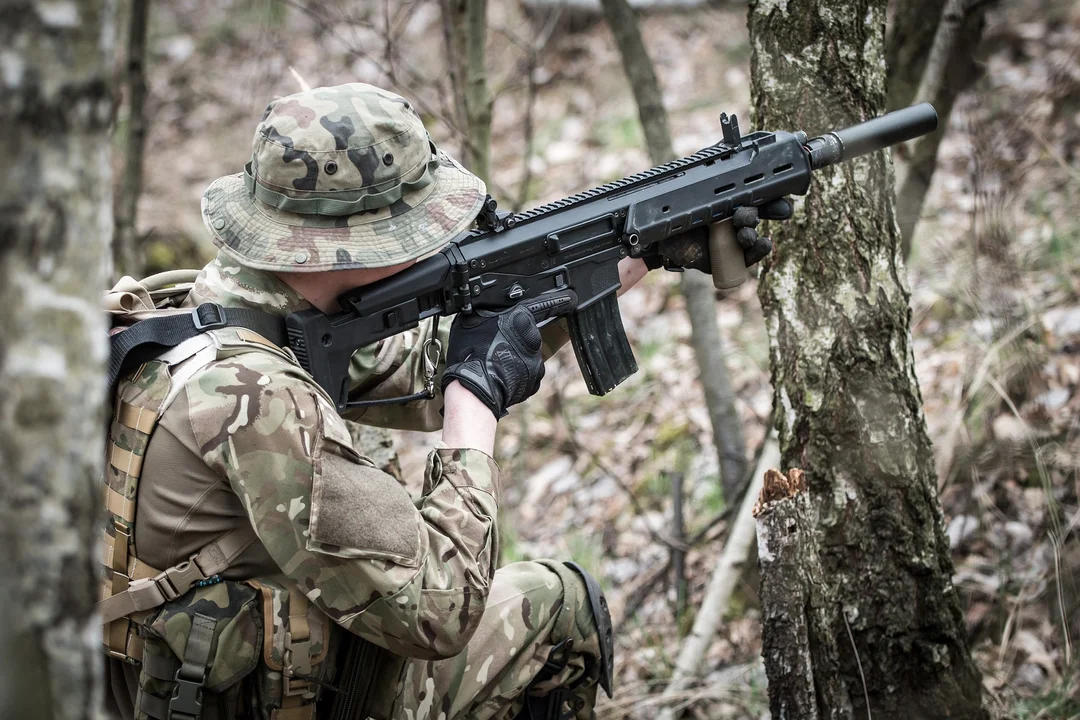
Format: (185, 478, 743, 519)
(187, 355, 499, 658)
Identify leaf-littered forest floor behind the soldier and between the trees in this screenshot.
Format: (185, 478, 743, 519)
(128, 0, 1080, 719)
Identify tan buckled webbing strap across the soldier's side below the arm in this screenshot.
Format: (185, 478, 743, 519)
(97, 524, 257, 623)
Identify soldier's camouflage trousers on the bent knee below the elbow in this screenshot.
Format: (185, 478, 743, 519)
(391, 560, 600, 720)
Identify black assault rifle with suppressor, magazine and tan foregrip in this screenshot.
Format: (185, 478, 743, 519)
(286, 104, 937, 410)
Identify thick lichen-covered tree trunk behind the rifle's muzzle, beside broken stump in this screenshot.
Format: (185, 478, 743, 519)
(750, 0, 987, 720)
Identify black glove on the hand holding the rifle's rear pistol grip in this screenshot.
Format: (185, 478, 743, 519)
(443, 305, 543, 418)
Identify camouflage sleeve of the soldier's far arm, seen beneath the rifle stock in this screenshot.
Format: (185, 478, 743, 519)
(345, 317, 570, 432)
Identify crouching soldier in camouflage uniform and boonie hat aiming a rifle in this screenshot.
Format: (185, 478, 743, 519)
(102, 84, 646, 720)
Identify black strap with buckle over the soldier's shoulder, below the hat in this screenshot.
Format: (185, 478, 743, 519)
(108, 302, 288, 393)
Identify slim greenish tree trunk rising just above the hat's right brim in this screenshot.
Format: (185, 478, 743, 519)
(442, 0, 491, 182)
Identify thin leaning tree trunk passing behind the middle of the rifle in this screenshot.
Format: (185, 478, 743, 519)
(603, 0, 746, 499)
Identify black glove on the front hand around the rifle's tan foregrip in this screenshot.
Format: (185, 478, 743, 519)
(642, 198, 794, 273)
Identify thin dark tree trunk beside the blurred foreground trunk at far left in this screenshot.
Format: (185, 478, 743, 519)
(113, 0, 150, 277)
